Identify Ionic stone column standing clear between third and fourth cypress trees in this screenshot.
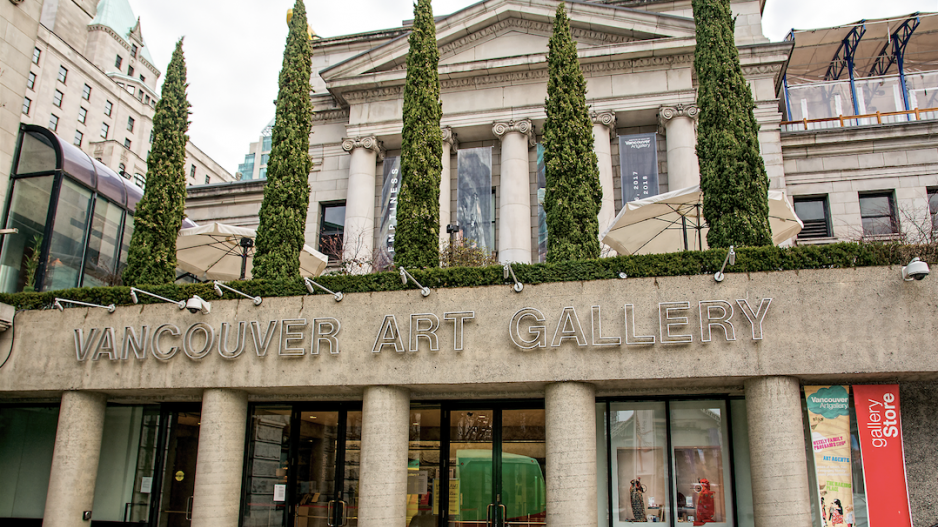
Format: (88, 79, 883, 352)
(492, 119, 536, 263)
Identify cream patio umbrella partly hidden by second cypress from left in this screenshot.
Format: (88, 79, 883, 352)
(176, 223, 329, 280)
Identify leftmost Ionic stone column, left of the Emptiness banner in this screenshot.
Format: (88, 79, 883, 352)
(342, 136, 384, 273)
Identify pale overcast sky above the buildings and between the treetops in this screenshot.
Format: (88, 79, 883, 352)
(129, 0, 938, 174)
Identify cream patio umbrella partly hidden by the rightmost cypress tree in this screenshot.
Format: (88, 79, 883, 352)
(600, 185, 804, 254)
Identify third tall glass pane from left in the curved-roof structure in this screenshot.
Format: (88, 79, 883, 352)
(81, 197, 123, 287)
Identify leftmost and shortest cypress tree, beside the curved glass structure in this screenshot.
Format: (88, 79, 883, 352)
(123, 39, 190, 286)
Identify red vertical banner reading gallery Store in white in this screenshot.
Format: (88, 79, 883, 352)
(853, 384, 912, 527)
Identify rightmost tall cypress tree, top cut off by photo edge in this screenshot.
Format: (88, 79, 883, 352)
(693, 0, 772, 247)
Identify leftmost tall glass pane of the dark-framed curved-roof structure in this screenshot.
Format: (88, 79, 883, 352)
(0, 176, 53, 293)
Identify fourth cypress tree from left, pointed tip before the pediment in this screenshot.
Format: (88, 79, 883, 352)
(544, 2, 603, 262)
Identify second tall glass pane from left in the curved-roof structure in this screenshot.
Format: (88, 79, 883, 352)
(42, 178, 91, 291)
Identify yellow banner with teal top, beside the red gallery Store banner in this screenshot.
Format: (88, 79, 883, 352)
(804, 385, 855, 527)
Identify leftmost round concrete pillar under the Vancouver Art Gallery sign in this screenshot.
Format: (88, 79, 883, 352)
(42, 392, 107, 527)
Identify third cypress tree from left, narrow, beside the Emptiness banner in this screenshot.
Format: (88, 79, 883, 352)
(394, 0, 448, 267)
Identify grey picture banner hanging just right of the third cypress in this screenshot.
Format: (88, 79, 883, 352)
(456, 146, 495, 251)
